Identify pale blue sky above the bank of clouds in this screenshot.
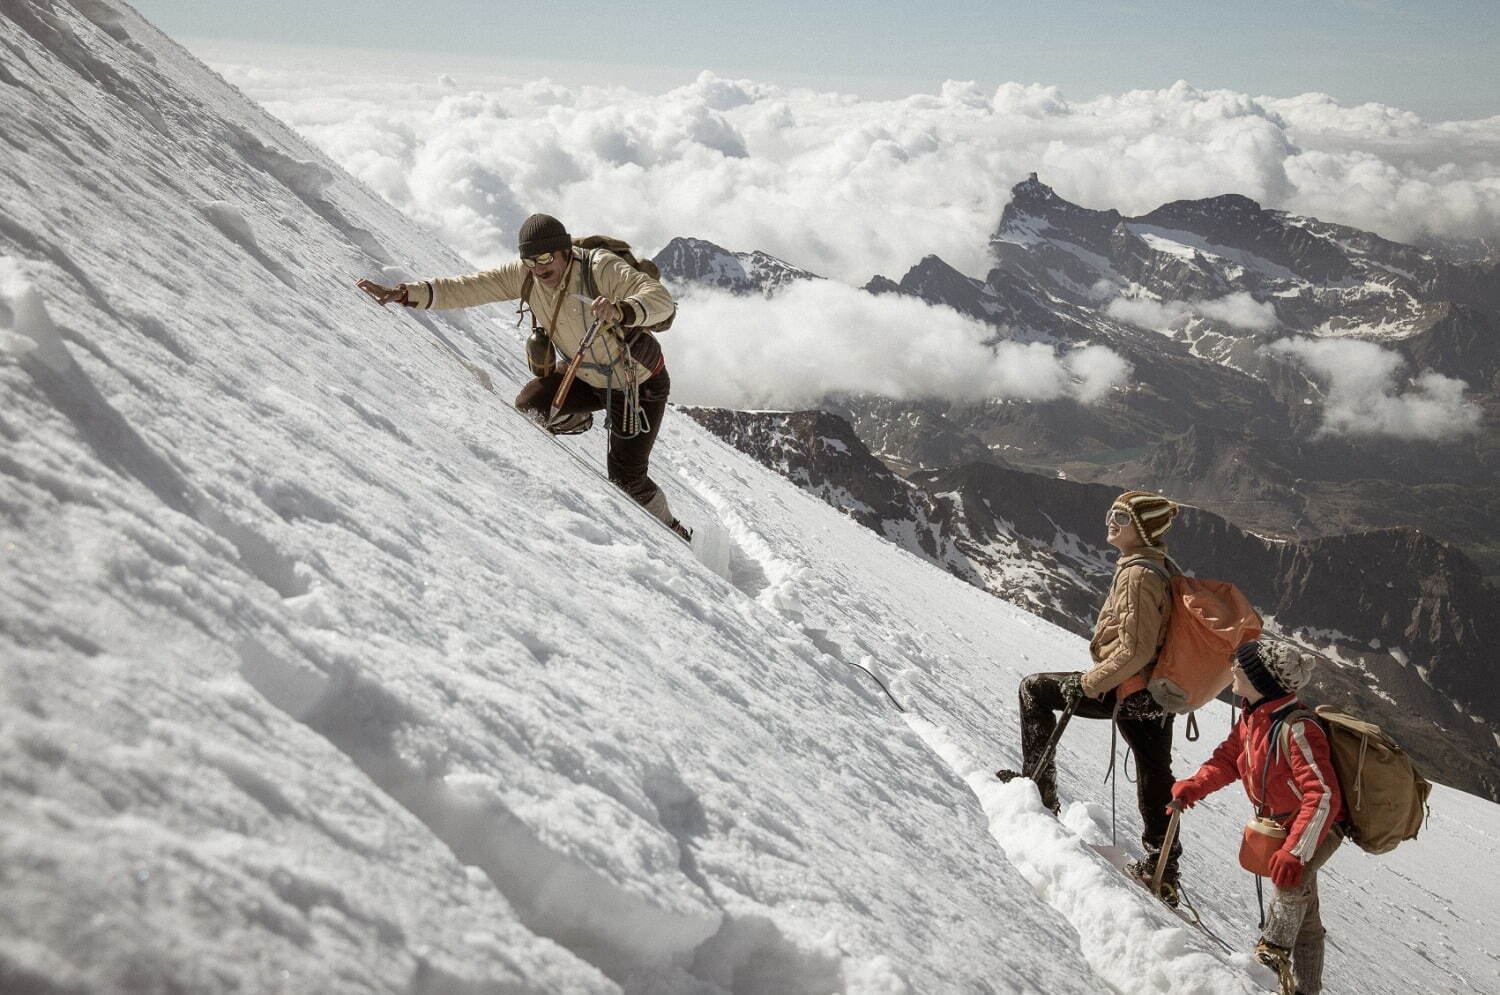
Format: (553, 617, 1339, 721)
(135, 0, 1500, 119)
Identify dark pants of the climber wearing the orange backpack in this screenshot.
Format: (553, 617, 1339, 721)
(1020, 674, 1182, 870)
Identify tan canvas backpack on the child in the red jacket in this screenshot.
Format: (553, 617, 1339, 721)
(1280, 705, 1433, 854)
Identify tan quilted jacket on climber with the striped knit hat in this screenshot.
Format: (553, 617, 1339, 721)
(1083, 546, 1172, 698)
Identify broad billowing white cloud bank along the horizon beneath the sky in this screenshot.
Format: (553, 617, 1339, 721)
(206, 50, 1500, 284)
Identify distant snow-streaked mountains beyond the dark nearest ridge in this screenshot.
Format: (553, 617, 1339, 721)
(659, 176, 1500, 579)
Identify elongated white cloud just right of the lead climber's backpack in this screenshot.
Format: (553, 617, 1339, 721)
(662, 281, 1130, 408)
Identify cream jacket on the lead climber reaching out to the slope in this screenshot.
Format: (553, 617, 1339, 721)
(407, 248, 677, 390)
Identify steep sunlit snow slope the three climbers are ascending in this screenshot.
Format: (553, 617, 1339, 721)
(0, 0, 1500, 993)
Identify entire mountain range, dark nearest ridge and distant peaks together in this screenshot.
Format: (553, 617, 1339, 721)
(657, 176, 1500, 798)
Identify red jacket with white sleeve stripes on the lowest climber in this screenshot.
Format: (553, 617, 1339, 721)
(1188, 695, 1349, 863)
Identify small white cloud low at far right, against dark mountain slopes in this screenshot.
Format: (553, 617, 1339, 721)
(1266, 336, 1482, 440)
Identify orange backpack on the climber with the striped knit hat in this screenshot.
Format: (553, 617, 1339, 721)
(1122, 557, 1262, 714)
